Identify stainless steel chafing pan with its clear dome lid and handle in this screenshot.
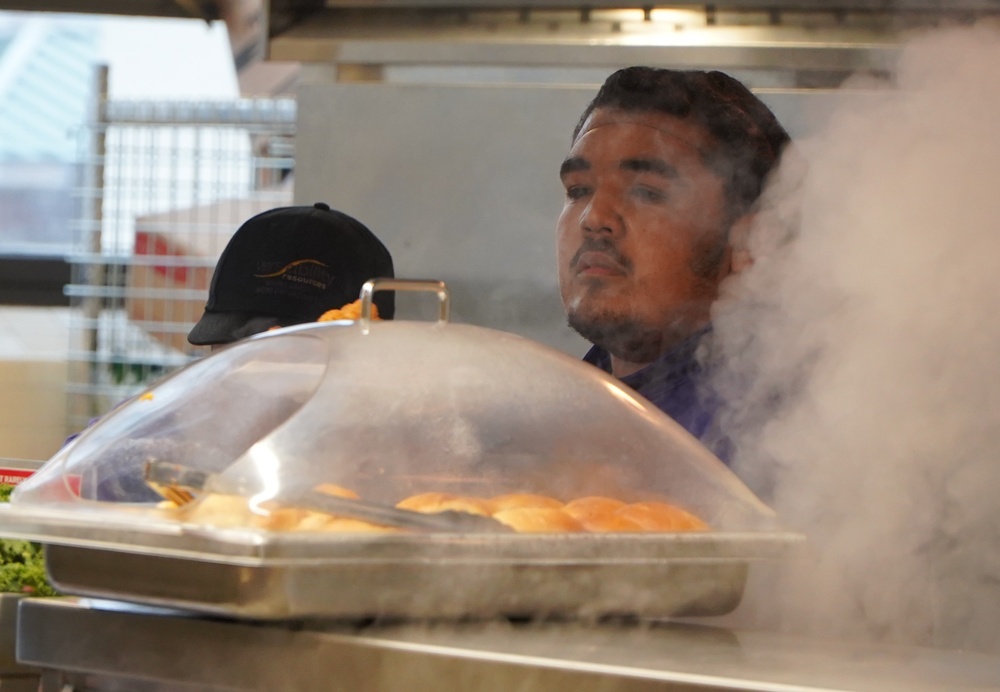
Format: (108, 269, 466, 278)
(0, 282, 799, 619)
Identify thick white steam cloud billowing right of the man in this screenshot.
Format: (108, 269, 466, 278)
(713, 26, 1000, 652)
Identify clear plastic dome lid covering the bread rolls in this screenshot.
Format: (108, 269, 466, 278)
(13, 282, 776, 531)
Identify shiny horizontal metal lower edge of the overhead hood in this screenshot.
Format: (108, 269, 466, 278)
(270, 20, 900, 77)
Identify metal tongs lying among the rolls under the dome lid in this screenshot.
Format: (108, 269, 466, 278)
(143, 458, 511, 533)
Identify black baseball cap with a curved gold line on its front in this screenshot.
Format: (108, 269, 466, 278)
(188, 202, 395, 346)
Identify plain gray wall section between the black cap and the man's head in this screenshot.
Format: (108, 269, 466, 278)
(295, 84, 593, 355)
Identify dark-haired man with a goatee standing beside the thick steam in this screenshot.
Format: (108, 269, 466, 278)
(557, 67, 789, 458)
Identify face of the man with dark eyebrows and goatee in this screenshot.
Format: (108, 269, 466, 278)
(557, 109, 729, 363)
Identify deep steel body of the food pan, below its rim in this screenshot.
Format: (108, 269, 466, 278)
(46, 546, 749, 620)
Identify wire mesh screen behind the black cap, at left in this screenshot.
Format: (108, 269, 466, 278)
(66, 99, 295, 430)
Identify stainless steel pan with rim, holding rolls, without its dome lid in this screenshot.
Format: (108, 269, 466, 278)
(0, 507, 797, 619)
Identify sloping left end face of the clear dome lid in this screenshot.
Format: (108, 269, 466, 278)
(15, 335, 327, 502)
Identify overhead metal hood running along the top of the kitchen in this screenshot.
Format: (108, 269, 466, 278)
(7, 0, 1000, 86)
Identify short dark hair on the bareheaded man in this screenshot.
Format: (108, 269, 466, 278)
(573, 67, 790, 217)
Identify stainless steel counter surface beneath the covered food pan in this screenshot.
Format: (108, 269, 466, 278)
(18, 599, 1000, 692)
